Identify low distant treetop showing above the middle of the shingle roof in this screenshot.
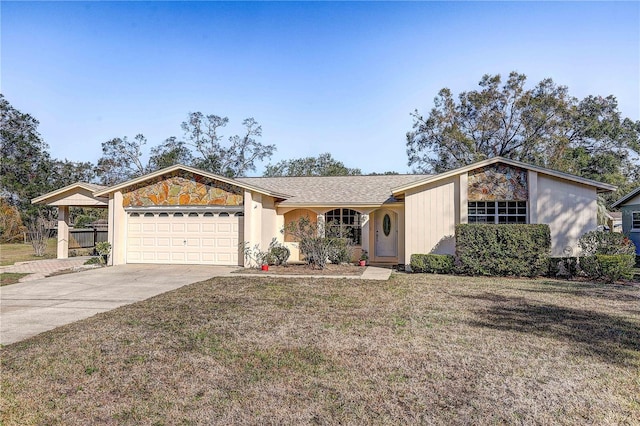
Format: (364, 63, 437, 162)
(264, 152, 362, 177)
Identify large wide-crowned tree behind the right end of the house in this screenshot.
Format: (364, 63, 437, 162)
(407, 72, 640, 200)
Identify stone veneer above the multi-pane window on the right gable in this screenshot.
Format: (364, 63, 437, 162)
(468, 164, 529, 201)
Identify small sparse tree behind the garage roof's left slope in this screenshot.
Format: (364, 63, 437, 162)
(96, 134, 148, 185)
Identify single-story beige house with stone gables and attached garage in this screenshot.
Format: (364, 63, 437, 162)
(33, 157, 615, 266)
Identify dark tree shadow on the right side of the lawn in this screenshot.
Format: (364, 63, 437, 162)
(463, 293, 640, 365)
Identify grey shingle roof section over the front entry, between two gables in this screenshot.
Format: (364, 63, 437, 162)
(236, 175, 428, 207)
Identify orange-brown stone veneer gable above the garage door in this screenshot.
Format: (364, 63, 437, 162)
(122, 171, 244, 207)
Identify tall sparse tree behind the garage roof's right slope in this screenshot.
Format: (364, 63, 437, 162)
(182, 112, 276, 177)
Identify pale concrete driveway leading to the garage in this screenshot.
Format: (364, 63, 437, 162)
(0, 265, 238, 345)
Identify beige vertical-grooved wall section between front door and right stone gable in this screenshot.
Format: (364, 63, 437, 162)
(403, 176, 466, 263)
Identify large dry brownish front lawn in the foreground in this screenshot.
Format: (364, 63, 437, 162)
(0, 274, 640, 425)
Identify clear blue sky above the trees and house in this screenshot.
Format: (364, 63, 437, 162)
(0, 1, 640, 175)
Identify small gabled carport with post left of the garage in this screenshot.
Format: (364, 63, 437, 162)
(31, 182, 109, 259)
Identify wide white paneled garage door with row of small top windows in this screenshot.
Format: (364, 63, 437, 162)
(127, 212, 244, 265)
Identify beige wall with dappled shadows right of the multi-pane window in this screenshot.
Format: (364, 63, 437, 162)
(536, 174, 598, 256)
